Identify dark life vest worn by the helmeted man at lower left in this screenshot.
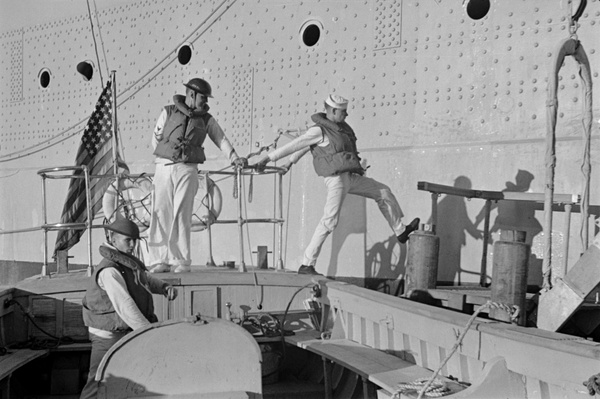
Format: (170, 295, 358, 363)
(83, 246, 158, 331)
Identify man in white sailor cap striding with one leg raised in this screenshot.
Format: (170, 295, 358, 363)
(256, 94, 419, 274)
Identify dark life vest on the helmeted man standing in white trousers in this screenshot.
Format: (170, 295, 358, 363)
(154, 105, 212, 163)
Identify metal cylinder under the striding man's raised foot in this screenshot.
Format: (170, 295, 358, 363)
(404, 224, 440, 294)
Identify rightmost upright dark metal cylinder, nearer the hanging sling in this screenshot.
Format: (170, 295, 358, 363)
(490, 230, 530, 326)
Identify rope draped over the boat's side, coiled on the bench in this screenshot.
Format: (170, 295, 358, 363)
(392, 301, 519, 399)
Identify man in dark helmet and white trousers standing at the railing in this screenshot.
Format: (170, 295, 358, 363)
(148, 78, 248, 273)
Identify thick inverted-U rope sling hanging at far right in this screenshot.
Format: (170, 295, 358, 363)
(542, 22, 592, 290)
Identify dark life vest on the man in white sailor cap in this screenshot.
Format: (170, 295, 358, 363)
(310, 113, 365, 177)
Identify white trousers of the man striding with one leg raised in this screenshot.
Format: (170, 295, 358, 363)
(302, 173, 405, 266)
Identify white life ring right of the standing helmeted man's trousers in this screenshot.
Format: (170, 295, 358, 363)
(191, 174, 223, 231)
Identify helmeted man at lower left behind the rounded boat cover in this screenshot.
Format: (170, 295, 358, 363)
(81, 219, 177, 398)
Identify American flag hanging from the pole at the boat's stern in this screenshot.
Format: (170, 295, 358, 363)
(54, 81, 127, 254)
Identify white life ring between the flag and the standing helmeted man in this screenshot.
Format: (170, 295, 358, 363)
(102, 175, 152, 232)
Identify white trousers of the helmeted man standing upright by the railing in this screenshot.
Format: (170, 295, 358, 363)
(148, 163, 199, 266)
